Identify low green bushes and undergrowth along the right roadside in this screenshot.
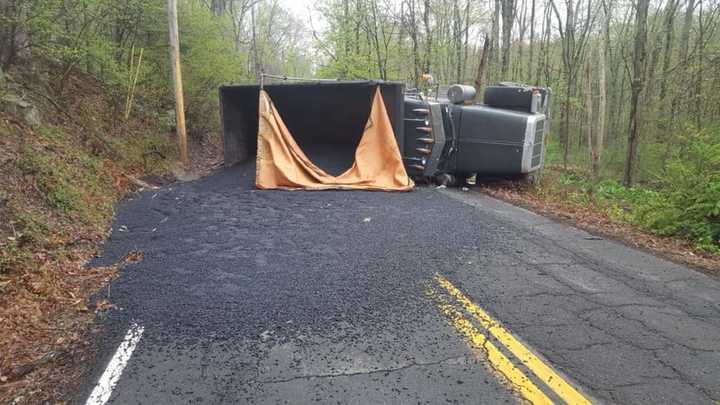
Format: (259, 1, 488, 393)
(552, 127, 720, 252)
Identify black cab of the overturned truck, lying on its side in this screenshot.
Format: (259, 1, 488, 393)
(403, 83, 550, 183)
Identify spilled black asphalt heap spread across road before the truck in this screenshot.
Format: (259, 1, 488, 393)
(95, 164, 500, 339)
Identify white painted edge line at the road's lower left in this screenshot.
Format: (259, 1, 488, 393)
(85, 323, 145, 405)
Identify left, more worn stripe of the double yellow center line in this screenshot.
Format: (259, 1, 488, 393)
(428, 287, 553, 405)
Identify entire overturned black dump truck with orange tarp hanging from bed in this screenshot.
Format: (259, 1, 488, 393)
(220, 81, 549, 191)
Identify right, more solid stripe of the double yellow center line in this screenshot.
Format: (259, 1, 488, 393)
(435, 273, 592, 405)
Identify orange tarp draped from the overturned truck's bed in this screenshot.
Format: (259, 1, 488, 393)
(255, 88, 414, 191)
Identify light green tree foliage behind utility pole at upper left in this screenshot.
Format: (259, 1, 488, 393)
(0, 0, 268, 138)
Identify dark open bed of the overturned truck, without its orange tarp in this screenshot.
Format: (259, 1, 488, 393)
(220, 81, 404, 175)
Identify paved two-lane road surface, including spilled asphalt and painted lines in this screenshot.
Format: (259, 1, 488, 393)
(72, 166, 720, 404)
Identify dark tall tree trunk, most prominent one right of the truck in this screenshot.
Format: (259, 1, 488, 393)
(623, 0, 648, 187)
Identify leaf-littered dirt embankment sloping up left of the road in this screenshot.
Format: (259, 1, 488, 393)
(0, 61, 217, 403)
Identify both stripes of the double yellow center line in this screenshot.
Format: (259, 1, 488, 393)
(428, 273, 592, 405)
